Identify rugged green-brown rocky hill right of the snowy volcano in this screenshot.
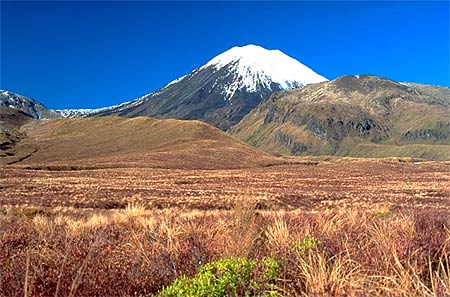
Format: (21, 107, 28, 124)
(230, 75, 450, 160)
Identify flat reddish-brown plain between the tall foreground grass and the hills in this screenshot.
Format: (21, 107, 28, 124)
(0, 160, 450, 210)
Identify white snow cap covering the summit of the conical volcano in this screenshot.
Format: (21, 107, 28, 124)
(201, 45, 327, 95)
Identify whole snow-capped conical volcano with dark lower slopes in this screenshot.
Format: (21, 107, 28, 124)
(89, 45, 327, 130)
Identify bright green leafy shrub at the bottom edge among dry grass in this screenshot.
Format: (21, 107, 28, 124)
(160, 258, 279, 296)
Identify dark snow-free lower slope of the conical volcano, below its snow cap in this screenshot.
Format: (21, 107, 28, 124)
(93, 66, 281, 130)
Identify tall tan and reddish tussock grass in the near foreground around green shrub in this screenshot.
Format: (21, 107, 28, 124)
(0, 202, 450, 296)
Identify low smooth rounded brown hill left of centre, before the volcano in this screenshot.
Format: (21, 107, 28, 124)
(4, 117, 278, 169)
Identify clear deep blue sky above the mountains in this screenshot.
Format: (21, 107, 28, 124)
(0, 1, 450, 108)
